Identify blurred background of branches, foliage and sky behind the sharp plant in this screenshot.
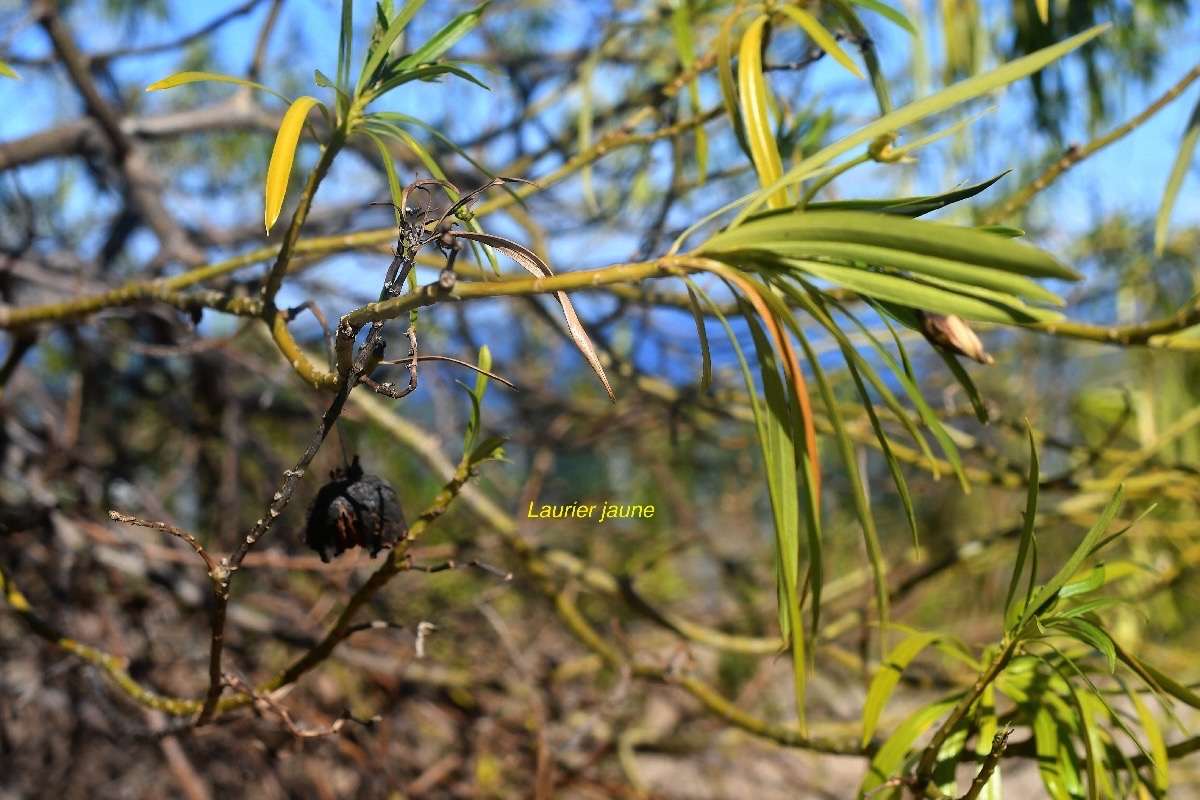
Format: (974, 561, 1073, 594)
(0, 0, 1200, 800)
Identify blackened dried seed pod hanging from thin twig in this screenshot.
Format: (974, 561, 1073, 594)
(304, 456, 408, 563)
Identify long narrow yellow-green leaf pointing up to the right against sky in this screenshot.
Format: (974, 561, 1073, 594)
(733, 24, 1109, 224)
